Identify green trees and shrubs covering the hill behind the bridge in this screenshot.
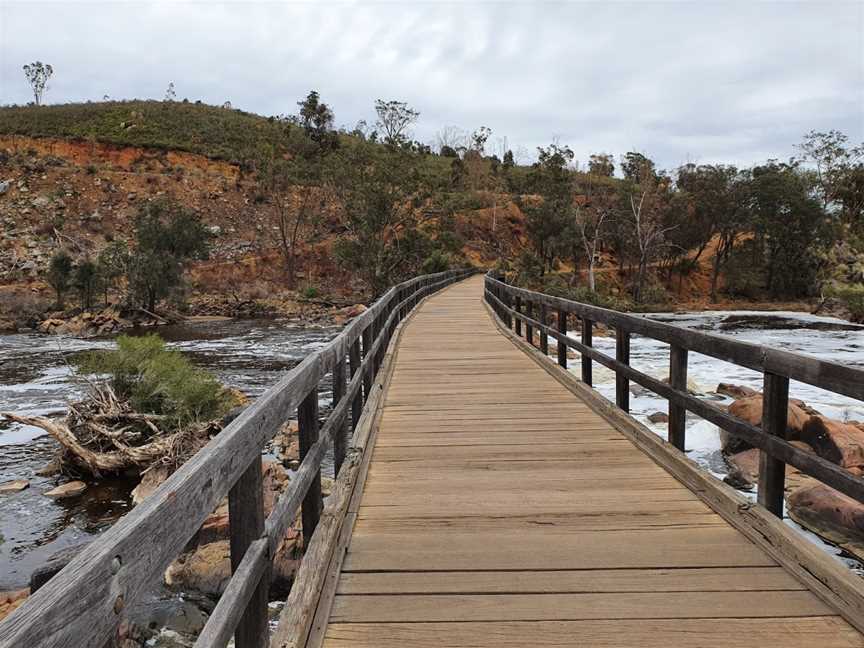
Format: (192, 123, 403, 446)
(0, 91, 864, 322)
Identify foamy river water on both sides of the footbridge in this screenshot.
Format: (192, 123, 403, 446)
(0, 312, 864, 591)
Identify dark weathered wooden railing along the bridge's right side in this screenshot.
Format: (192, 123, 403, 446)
(485, 275, 864, 517)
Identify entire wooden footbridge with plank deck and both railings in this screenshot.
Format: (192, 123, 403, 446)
(0, 272, 864, 648)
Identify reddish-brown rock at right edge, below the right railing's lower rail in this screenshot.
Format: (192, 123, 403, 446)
(786, 484, 864, 560)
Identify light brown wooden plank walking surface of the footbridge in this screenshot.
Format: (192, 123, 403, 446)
(324, 277, 864, 648)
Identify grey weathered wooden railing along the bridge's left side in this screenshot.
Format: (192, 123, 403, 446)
(0, 270, 472, 648)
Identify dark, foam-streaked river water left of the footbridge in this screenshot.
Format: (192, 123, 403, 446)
(0, 320, 338, 591)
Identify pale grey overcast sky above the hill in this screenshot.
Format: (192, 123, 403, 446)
(0, 0, 864, 168)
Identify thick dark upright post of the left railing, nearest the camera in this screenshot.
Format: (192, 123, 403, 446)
(228, 457, 270, 648)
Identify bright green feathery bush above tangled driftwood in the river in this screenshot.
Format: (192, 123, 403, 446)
(76, 334, 235, 428)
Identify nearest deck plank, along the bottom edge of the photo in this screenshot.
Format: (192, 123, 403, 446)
(324, 616, 864, 648)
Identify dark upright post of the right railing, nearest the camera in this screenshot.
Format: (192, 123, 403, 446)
(757, 372, 789, 518)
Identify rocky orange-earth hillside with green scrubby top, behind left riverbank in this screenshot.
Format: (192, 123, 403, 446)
(0, 101, 523, 328)
